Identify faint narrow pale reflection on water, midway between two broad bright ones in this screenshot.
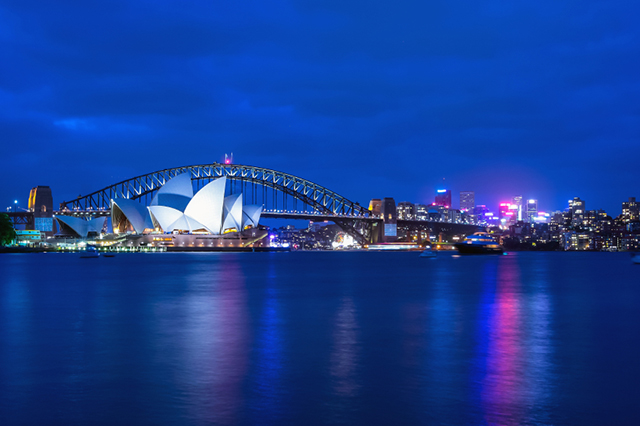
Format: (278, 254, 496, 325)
(329, 296, 360, 396)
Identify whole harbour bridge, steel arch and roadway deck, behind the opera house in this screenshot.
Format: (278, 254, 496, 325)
(57, 163, 479, 245)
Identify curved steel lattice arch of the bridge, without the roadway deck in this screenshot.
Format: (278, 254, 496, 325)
(60, 163, 370, 218)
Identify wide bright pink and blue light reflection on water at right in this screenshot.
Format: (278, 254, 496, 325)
(472, 258, 553, 425)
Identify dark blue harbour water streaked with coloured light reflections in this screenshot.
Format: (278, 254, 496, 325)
(0, 252, 640, 425)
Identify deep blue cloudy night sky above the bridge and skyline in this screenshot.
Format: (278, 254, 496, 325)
(0, 0, 640, 216)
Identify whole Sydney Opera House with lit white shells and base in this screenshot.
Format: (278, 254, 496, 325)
(56, 173, 267, 251)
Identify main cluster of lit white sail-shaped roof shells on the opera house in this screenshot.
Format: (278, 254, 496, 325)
(112, 173, 262, 235)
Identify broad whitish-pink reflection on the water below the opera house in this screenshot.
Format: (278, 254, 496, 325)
(176, 258, 249, 424)
